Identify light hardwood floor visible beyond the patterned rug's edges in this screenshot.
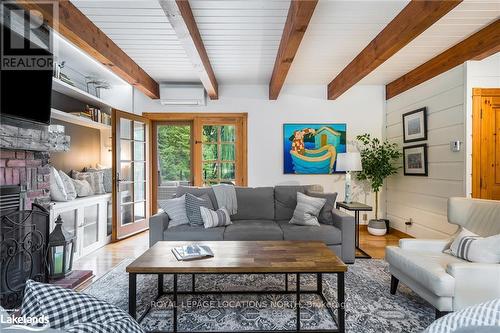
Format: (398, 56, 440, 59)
(73, 225, 409, 289)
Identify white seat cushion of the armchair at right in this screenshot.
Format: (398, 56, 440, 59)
(385, 246, 467, 297)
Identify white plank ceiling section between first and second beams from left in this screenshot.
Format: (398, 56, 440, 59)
(72, 0, 199, 82)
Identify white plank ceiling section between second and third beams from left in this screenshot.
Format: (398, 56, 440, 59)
(189, 0, 290, 84)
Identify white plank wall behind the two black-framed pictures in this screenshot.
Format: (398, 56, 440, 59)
(386, 65, 465, 238)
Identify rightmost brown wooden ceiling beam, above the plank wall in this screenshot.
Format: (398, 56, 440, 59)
(385, 19, 500, 99)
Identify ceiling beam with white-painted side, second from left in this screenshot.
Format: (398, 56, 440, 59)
(159, 0, 219, 100)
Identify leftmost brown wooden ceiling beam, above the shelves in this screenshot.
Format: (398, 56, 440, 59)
(18, 0, 160, 99)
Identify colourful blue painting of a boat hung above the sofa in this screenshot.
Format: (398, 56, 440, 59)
(283, 124, 346, 174)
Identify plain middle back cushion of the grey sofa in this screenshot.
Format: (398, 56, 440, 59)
(231, 187, 274, 220)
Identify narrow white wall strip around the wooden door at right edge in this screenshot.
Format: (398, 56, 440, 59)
(465, 53, 500, 196)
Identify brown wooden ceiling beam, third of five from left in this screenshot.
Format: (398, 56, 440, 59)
(269, 0, 318, 100)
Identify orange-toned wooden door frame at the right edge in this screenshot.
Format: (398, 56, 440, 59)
(472, 88, 500, 198)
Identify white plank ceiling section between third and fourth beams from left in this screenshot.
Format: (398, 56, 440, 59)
(285, 0, 409, 85)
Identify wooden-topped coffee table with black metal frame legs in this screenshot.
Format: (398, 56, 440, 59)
(127, 241, 347, 332)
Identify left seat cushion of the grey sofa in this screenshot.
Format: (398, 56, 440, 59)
(163, 224, 225, 241)
